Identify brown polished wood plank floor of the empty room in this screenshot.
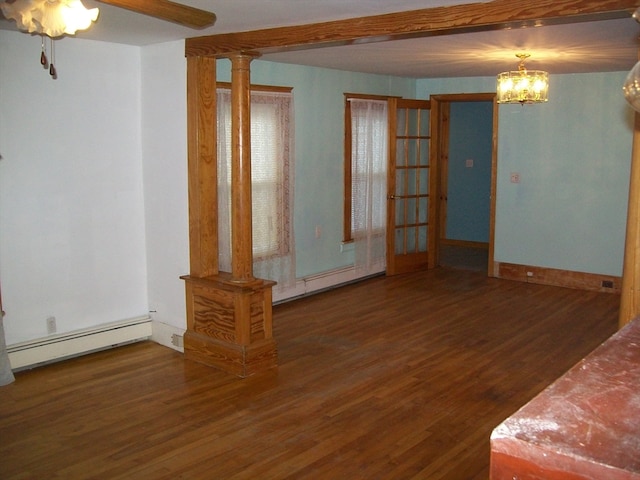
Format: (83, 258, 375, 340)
(0, 268, 619, 480)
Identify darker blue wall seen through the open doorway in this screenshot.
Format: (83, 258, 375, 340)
(445, 102, 493, 243)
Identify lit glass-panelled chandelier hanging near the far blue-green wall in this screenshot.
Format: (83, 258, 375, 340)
(497, 53, 549, 105)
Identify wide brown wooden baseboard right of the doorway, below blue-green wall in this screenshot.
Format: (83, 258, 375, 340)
(496, 262, 622, 294)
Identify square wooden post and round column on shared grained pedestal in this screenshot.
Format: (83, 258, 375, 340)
(182, 53, 277, 377)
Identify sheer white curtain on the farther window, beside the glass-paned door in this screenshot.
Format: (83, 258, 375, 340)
(350, 99, 388, 275)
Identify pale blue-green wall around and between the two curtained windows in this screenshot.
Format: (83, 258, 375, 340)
(217, 60, 416, 278)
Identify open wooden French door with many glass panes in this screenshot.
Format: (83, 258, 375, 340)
(387, 98, 436, 275)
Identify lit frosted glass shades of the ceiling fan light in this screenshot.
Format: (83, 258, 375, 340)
(0, 0, 99, 38)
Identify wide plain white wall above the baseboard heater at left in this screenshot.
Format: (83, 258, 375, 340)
(0, 31, 148, 345)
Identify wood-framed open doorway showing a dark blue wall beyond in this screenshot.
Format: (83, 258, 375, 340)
(431, 93, 498, 276)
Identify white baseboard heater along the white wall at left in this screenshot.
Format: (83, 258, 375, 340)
(7, 316, 151, 371)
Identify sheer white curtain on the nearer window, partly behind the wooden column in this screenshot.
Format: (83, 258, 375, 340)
(218, 89, 296, 291)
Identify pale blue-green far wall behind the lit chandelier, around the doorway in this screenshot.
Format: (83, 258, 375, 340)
(417, 72, 633, 275)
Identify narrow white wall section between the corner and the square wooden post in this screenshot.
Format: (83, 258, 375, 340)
(142, 41, 189, 334)
